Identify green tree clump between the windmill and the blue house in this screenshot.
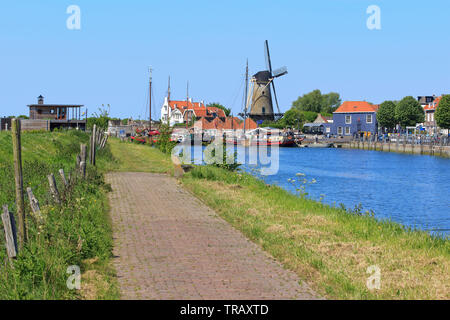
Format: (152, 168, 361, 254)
(292, 90, 341, 113)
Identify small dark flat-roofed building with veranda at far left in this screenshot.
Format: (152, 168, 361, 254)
(25, 95, 86, 130)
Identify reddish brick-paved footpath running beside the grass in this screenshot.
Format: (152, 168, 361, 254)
(107, 173, 316, 300)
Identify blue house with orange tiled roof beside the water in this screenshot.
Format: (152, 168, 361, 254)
(330, 101, 379, 136)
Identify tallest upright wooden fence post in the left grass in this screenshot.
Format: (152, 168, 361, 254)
(11, 119, 27, 248)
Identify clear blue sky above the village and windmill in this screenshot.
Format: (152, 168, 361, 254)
(0, 0, 450, 118)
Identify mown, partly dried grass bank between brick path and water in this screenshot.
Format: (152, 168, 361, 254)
(111, 140, 450, 299)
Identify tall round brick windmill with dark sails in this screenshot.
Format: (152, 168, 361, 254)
(245, 40, 288, 121)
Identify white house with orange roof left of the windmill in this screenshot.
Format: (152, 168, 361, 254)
(161, 97, 226, 126)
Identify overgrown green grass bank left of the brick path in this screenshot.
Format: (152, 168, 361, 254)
(0, 131, 119, 299)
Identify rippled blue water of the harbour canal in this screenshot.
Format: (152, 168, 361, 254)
(244, 148, 450, 235)
